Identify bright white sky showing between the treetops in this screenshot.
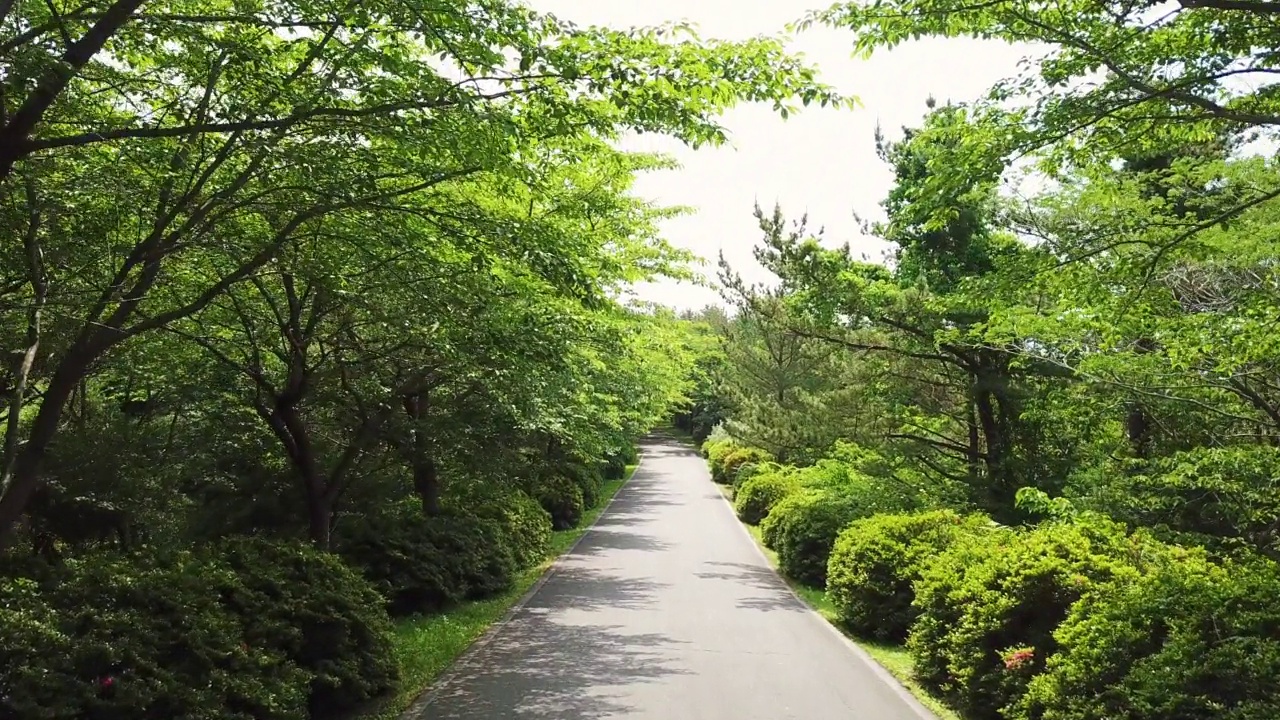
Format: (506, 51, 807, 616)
(526, 0, 1027, 309)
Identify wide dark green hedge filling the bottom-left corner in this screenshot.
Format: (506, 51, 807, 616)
(0, 538, 397, 720)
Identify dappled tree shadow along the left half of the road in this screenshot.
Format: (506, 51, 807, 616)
(411, 435, 689, 720)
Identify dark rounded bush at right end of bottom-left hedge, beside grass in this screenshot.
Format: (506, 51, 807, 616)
(207, 538, 397, 717)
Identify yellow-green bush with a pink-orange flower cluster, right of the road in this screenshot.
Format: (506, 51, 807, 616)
(908, 520, 1148, 720)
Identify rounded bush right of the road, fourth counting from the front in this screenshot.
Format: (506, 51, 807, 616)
(760, 489, 865, 588)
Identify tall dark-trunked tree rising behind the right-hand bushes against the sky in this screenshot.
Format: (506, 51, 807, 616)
(721, 106, 1065, 518)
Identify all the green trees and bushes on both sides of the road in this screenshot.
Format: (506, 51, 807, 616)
(0, 0, 1280, 720)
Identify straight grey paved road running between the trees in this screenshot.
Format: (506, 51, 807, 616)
(406, 439, 932, 720)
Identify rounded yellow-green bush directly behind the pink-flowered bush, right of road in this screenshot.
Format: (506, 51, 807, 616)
(827, 510, 986, 642)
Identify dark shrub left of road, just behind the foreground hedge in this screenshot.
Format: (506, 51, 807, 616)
(339, 504, 524, 615)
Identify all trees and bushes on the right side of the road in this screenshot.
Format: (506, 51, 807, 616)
(677, 0, 1280, 720)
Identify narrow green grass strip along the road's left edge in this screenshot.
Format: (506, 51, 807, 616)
(361, 465, 636, 720)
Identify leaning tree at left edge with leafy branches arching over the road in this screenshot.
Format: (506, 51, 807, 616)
(0, 0, 840, 542)
